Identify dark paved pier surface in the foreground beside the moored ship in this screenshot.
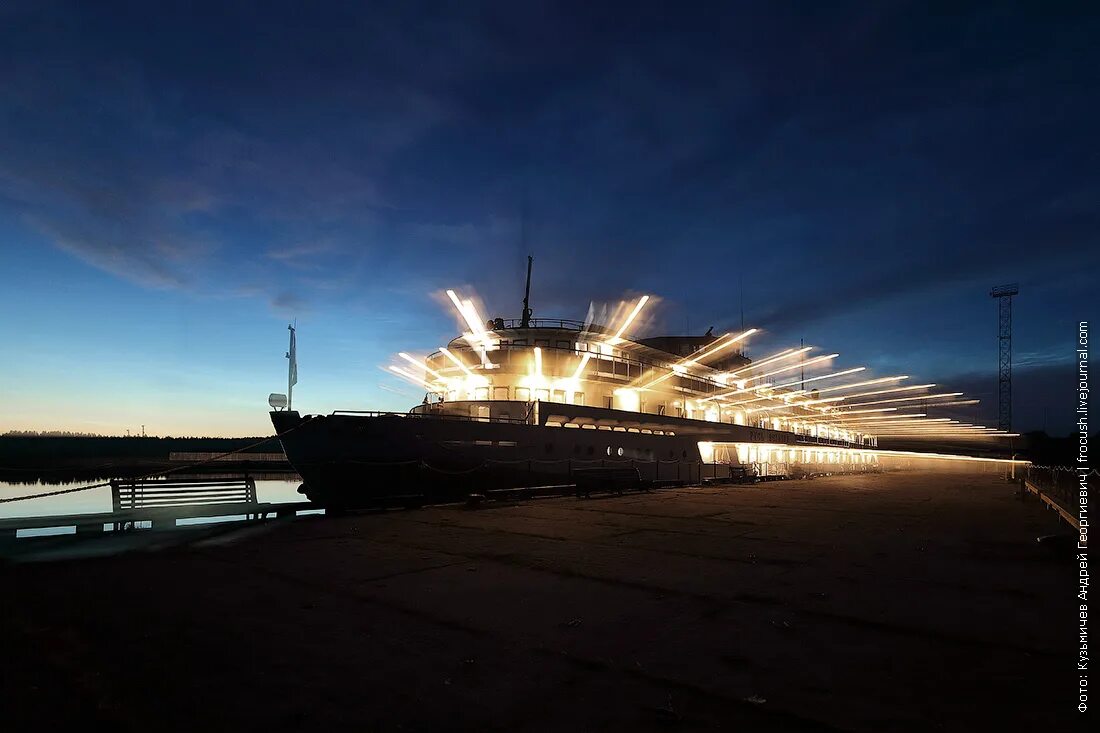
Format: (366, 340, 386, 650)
(0, 473, 1077, 732)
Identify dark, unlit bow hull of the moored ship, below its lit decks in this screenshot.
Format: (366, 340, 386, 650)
(271, 411, 703, 507)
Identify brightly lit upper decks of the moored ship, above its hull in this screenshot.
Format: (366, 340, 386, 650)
(415, 318, 866, 445)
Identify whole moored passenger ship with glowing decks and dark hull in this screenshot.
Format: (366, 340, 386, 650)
(271, 259, 905, 507)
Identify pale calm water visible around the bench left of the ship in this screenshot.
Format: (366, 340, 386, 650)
(0, 473, 305, 518)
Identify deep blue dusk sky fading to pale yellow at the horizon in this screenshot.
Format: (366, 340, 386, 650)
(0, 0, 1100, 435)
